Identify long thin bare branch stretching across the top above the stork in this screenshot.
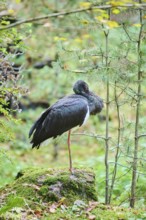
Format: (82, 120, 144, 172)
(0, 3, 146, 31)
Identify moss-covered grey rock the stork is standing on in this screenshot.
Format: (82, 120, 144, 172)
(0, 168, 97, 209)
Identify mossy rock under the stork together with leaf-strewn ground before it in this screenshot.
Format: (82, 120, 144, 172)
(0, 168, 146, 220)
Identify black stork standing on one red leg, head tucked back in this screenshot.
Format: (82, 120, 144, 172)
(29, 80, 103, 173)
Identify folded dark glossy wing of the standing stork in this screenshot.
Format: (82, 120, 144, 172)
(29, 97, 88, 147)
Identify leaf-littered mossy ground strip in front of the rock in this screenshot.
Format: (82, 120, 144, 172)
(0, 200, 146, 220)
